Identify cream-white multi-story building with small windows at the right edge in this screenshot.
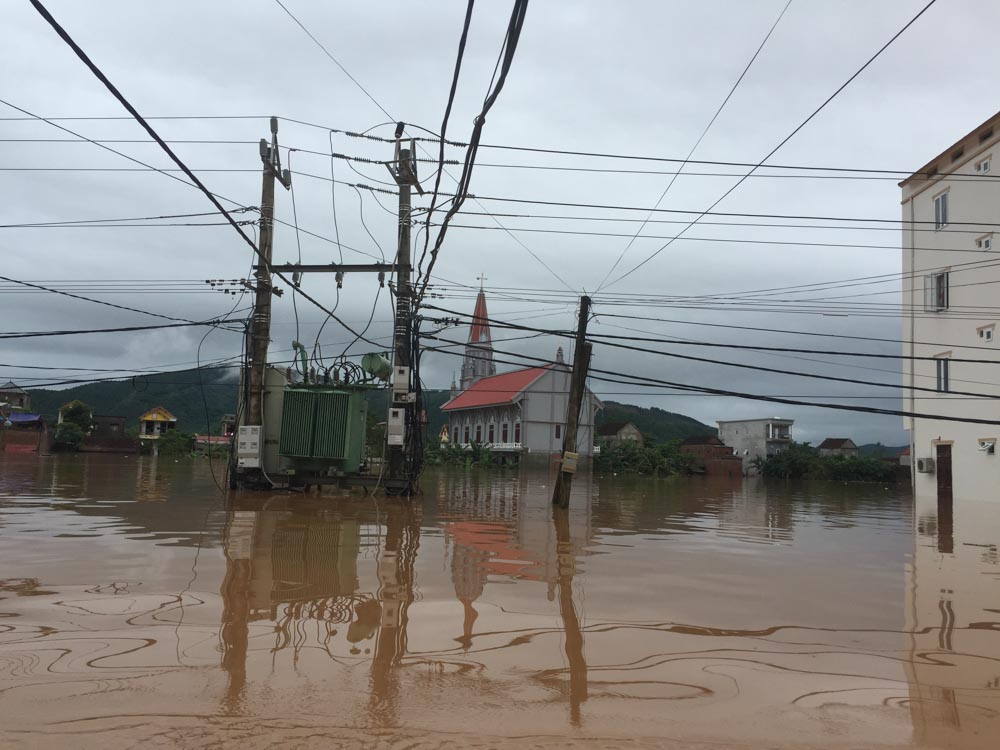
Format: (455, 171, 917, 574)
(900, 113, 1000, 506)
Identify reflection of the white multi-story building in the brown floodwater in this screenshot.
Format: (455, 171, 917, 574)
(906, 484, 1000, 750)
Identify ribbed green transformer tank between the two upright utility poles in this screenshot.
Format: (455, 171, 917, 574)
(278, 384, 370, 476)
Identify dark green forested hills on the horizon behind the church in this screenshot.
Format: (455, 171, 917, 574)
(28, 368, 716, 450)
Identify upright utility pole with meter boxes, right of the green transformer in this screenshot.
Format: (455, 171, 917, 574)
(385, 137, 423, 495)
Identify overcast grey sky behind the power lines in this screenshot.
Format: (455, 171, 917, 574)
(0, 0, 1000, 444)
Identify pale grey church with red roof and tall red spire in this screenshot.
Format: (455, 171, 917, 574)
(441, 289, 603, 456)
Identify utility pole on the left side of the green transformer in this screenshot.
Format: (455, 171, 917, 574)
(242, 117, 292, 432)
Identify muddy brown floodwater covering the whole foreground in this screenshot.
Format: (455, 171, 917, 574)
(0, 455, 1000, 750)
